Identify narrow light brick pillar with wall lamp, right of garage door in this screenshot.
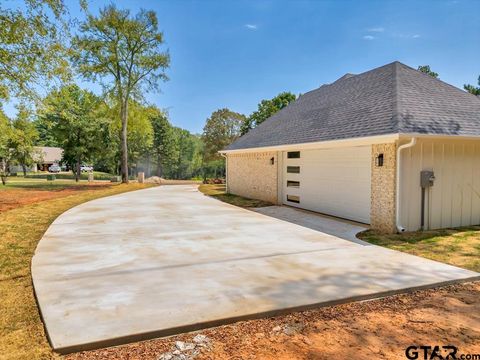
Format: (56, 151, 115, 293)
(370, 143, 397, 233)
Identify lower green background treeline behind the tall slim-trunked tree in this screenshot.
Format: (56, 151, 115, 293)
(0, 84, 296, 183)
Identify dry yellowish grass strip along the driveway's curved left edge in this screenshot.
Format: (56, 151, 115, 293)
(0, 182, 155, 359)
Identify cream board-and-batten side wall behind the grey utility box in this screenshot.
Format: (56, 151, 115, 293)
(400, 139, 480, 231)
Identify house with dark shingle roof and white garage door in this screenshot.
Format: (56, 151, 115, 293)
(221, 62, 480, 233)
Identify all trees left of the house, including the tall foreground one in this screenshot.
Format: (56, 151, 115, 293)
(0, 0, 295, 182)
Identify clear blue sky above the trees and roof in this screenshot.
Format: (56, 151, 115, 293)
(4, 0, 480, 133)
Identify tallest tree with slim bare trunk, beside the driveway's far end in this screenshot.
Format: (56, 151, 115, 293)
(73, 5, 170, 182)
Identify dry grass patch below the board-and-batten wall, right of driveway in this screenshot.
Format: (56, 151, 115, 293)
(357, 226, 480, 272)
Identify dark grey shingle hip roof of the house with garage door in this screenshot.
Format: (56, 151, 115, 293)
(226, 62, 480, 150)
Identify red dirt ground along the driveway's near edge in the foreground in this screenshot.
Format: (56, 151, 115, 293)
(67, 282, 480, 360)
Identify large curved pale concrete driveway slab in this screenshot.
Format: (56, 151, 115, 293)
(32, 186, 478, 353)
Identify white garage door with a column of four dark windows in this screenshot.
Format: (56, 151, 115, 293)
(283, 146, 371, 224)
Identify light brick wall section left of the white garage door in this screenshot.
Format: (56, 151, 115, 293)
(227, 152, 278, 203)
